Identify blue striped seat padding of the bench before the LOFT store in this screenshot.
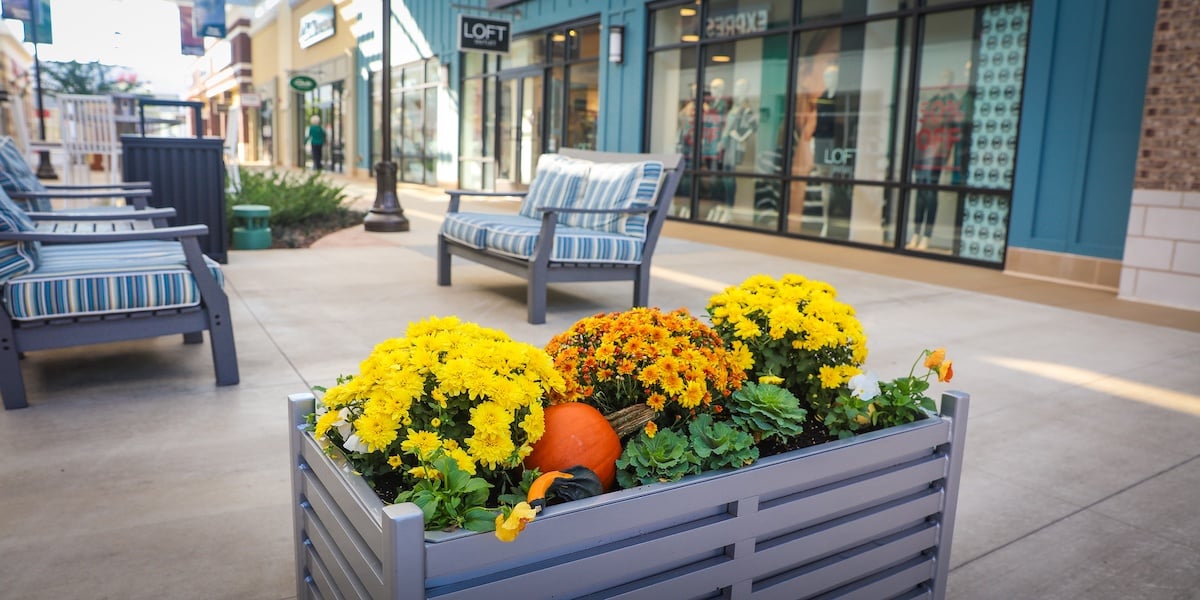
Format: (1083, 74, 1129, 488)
(485, 222, 643, 264)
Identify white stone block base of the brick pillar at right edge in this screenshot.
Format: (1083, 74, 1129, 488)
(1118, 190, 1200, 311)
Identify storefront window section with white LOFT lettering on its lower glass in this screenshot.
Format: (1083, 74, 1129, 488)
(787, 20, 908, 245)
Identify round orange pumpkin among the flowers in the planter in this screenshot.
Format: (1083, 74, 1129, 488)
(524, 402, 622, 491)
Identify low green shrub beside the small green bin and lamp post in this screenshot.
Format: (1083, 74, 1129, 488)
(226, 167, 362, 247)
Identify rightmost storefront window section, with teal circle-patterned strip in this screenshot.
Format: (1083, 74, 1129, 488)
(904, 2, 1030, 263)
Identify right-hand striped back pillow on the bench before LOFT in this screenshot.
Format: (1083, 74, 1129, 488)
(562, 161, 664, 238)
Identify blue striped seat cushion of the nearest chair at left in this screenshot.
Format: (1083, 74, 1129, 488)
(4, 241, 224, 320)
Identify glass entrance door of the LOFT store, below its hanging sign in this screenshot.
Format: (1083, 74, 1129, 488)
(496, 72, 544, 191)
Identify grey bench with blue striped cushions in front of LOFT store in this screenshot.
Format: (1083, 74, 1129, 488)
(438, 149, 683, 324)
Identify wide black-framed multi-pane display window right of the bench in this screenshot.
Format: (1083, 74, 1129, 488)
(646, 0, 1030, 263)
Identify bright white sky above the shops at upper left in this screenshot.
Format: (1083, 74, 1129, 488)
(0, 0, 196, 96)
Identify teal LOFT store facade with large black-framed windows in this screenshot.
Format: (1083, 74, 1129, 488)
(372, 0, 1157, 290)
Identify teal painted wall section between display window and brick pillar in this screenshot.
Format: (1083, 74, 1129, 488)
(1008, 0, 1158, 259)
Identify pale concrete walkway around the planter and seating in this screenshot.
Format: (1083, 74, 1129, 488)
(0, 172, 1200, 600)
